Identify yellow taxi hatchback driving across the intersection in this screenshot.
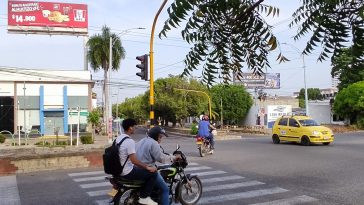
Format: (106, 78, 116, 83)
(272, 116, 334, 146)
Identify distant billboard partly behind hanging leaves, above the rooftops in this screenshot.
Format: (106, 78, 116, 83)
(235, 73, 281, 89)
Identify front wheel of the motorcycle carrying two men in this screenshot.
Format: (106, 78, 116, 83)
(178, 176, 202, 205)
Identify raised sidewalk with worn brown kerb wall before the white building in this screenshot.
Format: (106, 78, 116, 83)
(0, 135, 109, 176)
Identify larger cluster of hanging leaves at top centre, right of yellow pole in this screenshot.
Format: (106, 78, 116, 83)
(159, 0, 287, 86)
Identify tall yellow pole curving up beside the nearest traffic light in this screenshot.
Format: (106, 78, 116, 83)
(149, 0, 168, 126)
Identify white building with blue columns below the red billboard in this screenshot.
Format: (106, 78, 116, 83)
(0, 67, 94, 135)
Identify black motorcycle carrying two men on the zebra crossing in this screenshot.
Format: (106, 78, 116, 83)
(106, 144, 202, 205)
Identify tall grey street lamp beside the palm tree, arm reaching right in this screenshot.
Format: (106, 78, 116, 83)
(105, 27, 145, 142)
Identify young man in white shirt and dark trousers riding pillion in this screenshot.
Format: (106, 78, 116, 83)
(116, 119, 158, 205)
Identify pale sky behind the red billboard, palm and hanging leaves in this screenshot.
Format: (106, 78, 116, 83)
(0, 0, 331, 103)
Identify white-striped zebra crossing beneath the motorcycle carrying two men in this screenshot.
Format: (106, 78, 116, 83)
(68, 163, 319, 205)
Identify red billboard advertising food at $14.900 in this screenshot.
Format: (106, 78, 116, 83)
(8, 1, 88, 35)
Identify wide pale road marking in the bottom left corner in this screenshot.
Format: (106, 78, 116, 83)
(0, 175, 20, 205)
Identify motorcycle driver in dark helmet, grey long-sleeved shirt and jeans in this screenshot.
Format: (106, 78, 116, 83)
(136, 126, 181, 205)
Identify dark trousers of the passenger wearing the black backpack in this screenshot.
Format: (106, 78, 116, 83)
(123, 166, 158, 198)
